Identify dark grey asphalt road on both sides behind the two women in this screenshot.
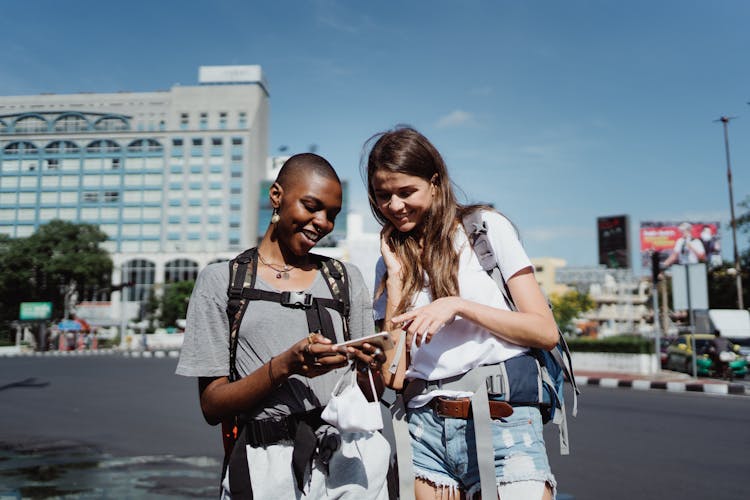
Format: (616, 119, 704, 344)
(0, 356, 750, 500)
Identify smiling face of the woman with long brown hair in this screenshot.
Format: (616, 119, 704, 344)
(372, 169, 435, 233)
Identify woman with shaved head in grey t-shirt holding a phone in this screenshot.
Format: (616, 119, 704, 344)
(177, 153, 389, 500)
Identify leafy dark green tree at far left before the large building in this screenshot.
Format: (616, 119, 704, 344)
(0, 220, 112, 323)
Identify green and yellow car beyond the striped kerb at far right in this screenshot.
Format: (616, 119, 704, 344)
(664, 333, 748, 378)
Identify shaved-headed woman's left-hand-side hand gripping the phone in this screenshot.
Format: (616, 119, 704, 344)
(275, 333, 349, 378)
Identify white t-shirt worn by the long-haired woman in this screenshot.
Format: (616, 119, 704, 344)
(374, 210, 531, 407)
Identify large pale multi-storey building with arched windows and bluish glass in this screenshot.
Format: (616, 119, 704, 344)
(0, 66, 269, 324)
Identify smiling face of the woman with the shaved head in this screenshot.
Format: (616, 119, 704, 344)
(270, 173, 341, 257)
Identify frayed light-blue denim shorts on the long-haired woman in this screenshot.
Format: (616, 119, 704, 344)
(407, 405, 556, 498)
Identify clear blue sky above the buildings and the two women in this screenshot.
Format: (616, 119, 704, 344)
(0, 0, 750, 271)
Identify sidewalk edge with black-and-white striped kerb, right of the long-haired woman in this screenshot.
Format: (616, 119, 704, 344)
(575, 370, 750, 396)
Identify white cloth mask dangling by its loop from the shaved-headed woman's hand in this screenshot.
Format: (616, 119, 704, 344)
(320, 363, 383, 433)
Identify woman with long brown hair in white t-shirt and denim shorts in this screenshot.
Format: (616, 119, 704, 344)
(366, 127, 558, 500)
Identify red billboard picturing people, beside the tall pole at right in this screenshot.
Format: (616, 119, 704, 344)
(641, 221, 722, 269)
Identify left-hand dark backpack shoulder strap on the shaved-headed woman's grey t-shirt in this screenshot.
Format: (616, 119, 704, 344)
(227, 248, 258, 381)
